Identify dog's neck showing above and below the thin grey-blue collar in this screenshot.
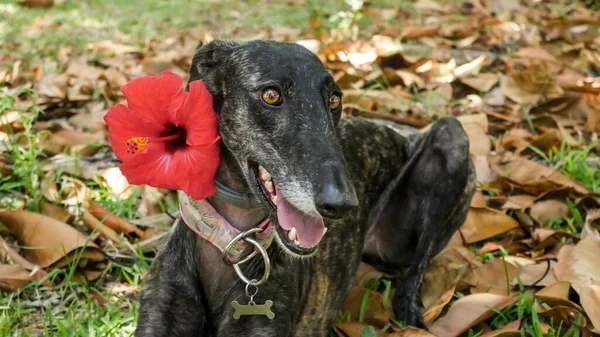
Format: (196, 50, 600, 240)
(208, 145, 267, 231)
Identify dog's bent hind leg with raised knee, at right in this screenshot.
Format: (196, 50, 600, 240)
(364, 118, 475, 328)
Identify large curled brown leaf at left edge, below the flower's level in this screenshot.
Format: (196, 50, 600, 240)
(0, 210, 105, 268)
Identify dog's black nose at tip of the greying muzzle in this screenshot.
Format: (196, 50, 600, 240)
(315, 166, 358, 219)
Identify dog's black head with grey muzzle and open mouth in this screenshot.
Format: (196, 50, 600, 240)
(190, 41, 358, 255)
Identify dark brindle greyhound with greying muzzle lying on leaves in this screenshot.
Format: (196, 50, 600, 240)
(136, 41, 475, 337)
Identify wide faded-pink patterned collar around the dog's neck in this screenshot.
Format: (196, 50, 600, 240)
(179, 192, 274, 263)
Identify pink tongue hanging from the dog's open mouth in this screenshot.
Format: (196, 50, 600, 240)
(277, 194, 325, 248)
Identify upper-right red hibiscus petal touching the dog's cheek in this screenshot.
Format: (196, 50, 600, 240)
(176, 81, 219, 145)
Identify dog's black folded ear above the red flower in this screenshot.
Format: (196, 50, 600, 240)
(188, 40, 239, 105)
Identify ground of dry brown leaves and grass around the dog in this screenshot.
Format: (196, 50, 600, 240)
(0, 0, 600, 337)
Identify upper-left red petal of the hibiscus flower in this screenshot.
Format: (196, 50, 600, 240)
(121, 71, 188, 126)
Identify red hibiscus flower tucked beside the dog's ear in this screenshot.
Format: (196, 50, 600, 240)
(104, 71, 221, 199)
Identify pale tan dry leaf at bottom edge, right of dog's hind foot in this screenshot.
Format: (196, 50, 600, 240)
(430, 293, 517, 337)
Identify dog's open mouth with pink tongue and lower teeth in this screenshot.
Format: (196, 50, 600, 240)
(255, 165, 327, 255)
